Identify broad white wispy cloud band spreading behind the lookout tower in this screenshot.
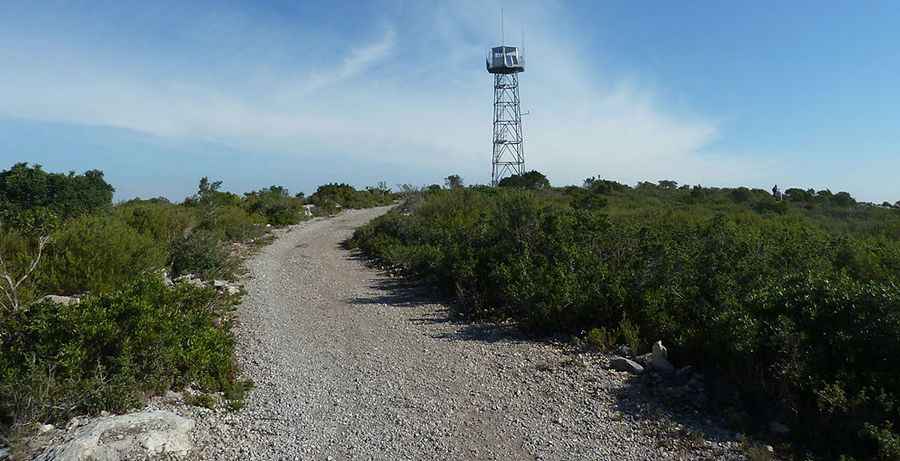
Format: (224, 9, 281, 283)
(0, 2, 773, 189)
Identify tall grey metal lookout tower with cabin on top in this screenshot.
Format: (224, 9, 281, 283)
(485, 45, 525, 186)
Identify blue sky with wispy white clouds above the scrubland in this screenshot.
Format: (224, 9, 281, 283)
(0, 0, 900, 202)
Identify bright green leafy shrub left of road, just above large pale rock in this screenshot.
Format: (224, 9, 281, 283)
(0, 277, 246, 430)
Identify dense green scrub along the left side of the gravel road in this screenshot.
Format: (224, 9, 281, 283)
(0, 163, 392, 446)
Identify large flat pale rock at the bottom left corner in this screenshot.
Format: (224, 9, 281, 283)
(36, 410, 194, 461)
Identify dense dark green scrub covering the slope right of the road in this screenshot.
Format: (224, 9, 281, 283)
(350, 175, 900, 460)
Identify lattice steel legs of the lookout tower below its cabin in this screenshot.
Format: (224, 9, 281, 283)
(491, 72, 525, 186)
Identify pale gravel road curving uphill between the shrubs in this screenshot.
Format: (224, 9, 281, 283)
(195, 208, 741, 460)
